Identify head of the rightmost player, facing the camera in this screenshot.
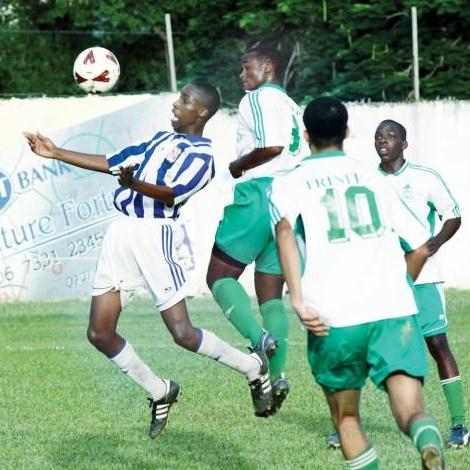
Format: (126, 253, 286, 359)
(374, 119, 408, 166)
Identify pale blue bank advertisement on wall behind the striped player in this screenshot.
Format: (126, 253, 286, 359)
(0, 98, 202, 301)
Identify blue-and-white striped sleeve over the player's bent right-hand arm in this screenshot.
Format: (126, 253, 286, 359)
(168, 152, 215, 205)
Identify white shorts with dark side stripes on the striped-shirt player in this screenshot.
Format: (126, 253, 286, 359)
(93, 215, 186, 310)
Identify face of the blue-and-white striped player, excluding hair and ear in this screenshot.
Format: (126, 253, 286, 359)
(171, 85, 207, 132)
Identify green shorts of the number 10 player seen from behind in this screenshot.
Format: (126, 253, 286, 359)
(308, 315, 427, 393)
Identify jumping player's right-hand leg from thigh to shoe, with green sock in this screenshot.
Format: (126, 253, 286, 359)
(255, 271, 289, 413)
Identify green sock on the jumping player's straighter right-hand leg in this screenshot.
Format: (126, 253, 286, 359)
(260, 299, 289, 380)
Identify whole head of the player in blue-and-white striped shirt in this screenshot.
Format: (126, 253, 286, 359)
(171, 82, 220, 135)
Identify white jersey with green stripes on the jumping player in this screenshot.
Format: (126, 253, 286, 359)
(236, 83, 309, 181)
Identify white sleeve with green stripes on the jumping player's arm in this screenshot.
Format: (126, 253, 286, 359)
(248, 89, 292, 148)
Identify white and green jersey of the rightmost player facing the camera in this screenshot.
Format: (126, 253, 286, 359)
(379, 160, 460, 284)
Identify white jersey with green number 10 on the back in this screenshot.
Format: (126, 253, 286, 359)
(271, 151, 427, 327)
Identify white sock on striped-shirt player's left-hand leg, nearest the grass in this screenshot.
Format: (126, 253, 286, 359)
(110, 341, 169, 400)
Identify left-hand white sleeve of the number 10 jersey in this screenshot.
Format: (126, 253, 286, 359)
(268, 174, 300, 233)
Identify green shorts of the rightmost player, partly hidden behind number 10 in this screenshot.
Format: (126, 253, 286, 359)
(414, 282, 447, 337)
